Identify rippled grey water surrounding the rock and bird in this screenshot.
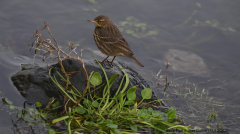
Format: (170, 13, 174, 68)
(0, 0, 240, 134)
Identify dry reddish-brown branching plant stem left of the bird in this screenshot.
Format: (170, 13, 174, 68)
(28, 22, 89, 106)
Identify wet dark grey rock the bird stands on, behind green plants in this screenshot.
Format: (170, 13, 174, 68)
(11, 59, 157, 107)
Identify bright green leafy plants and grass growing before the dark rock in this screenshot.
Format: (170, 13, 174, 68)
(42, 54, 192, 134)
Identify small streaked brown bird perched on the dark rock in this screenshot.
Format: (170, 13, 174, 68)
(88, 15, 144, 67)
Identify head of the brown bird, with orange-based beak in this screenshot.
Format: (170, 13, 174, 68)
(88, 15, 112, 28)
